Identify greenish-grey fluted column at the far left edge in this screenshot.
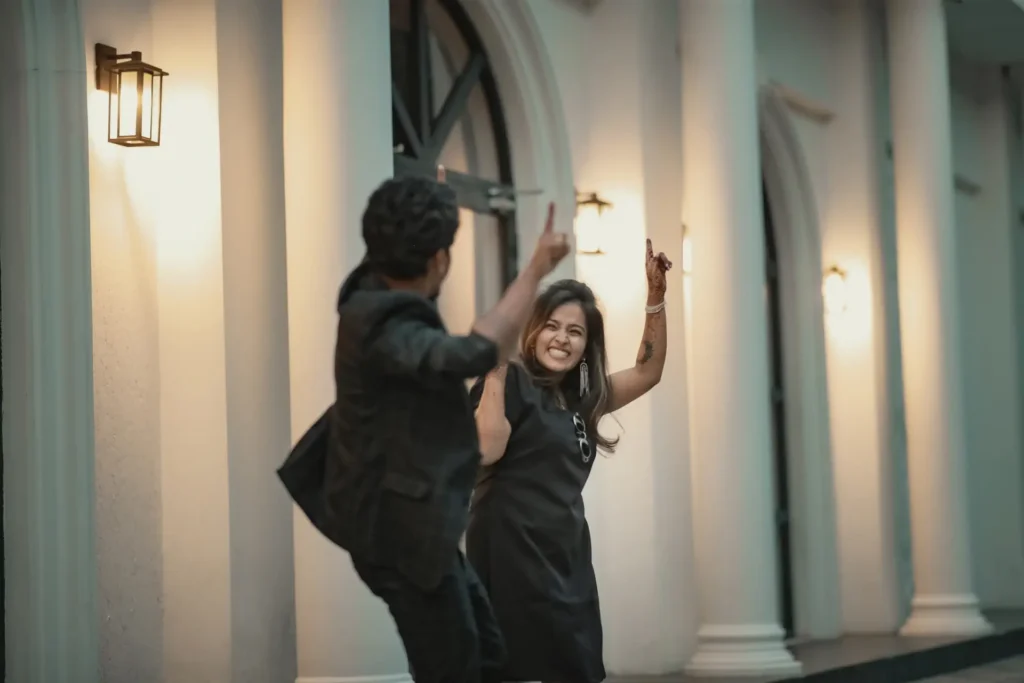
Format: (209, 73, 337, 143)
(0, 0, 99, 683)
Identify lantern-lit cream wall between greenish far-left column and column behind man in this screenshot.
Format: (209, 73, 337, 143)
(82, 0, 295, 683)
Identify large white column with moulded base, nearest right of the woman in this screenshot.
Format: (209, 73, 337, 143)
(680, 0, 800, 676)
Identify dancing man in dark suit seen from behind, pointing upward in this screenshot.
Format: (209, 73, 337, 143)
(325, 177, 568, 683)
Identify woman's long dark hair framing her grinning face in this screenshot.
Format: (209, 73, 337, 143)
(520, 280, 618, 453)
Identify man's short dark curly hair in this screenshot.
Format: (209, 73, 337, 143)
(362, 177, 459, 280)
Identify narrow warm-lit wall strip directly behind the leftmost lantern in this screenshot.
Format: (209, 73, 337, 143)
(82, 0, 164, 682)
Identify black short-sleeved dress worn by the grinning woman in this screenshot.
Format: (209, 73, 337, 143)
(466, 364, 605, 683)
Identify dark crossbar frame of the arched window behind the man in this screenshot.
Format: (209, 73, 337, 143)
(390, 0, 517, 287)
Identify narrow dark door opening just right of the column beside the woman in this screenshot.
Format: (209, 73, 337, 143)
(761, 184, 795, 638)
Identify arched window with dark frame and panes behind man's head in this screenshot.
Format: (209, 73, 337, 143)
(390, 0, 517, 331)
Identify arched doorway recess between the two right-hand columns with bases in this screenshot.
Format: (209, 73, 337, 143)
(759, 85, 842, 639)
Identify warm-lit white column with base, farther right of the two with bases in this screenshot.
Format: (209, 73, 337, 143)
(888, 0, 991, 636)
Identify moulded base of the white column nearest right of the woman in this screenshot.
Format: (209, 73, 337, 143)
(685, 624, 802, 677)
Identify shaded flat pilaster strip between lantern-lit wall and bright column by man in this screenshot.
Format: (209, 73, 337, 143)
(216, 0, 296, 683)
